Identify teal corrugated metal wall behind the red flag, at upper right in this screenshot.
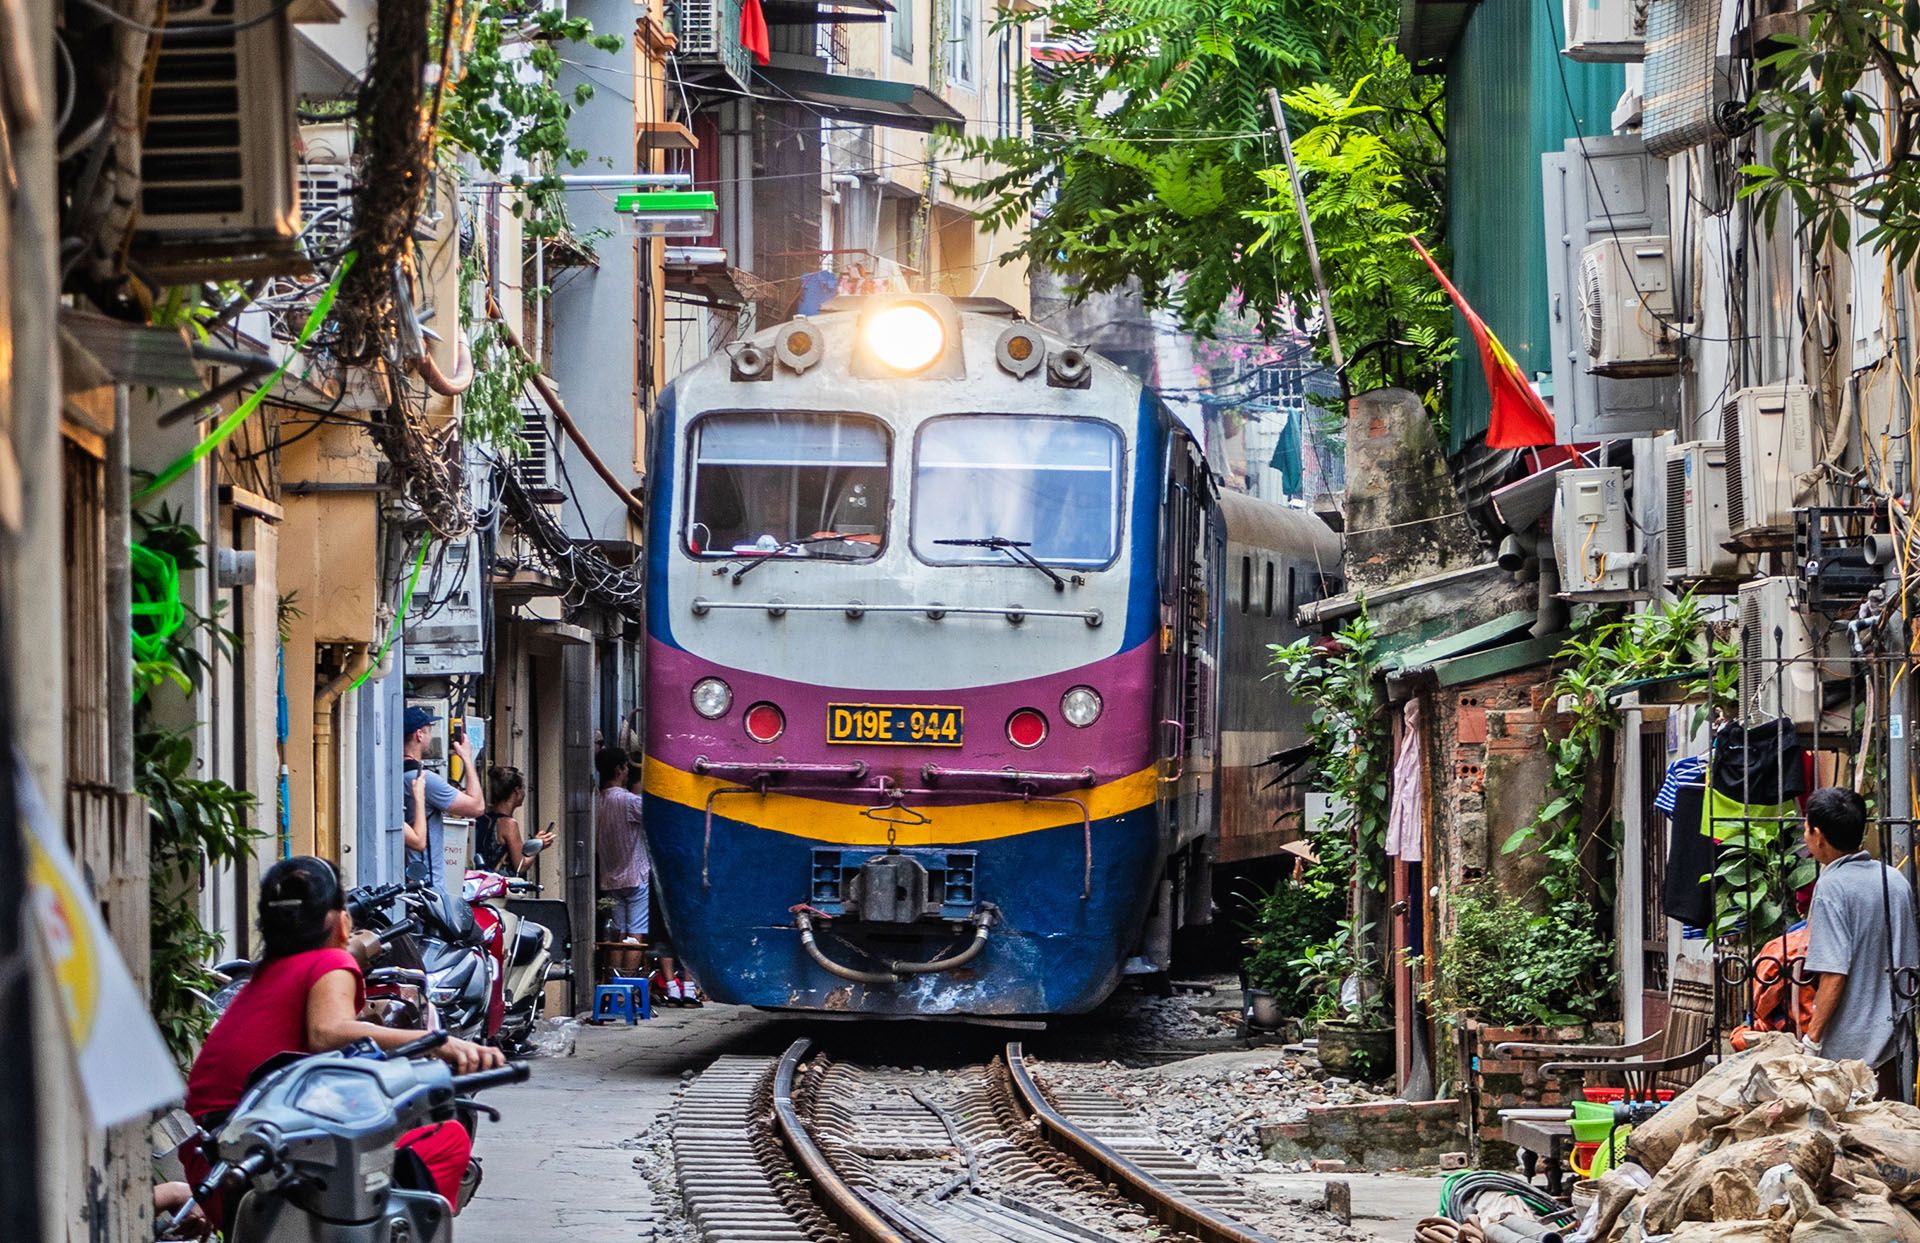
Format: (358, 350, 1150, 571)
(1443, 0, 1626, 451)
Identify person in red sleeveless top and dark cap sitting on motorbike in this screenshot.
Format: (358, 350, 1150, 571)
(186, 857, 505, 1208)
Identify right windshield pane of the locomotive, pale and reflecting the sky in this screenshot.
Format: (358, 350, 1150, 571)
(914, 415, 1121, 567)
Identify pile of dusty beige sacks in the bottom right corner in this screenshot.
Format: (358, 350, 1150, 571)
(1574, 1034, 1920, 1243)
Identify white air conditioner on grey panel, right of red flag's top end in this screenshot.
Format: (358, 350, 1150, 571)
(1580, 234, 1680, 377)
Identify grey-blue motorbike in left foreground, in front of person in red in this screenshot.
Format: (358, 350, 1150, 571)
(157, 1032, 528, 1243)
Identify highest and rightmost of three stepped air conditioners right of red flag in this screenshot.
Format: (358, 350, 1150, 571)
(1722, 384, 1814, 548)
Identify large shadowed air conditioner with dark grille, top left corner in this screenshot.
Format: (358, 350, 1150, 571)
(134, 0, 303, 275)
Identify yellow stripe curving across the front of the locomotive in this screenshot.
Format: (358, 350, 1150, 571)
(645, 757, 1158, 845)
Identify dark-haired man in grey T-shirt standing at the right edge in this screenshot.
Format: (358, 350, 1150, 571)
(1803, 786, 1920, 1101)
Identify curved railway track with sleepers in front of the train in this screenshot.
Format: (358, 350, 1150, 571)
(672, 1039, 1275, 1243)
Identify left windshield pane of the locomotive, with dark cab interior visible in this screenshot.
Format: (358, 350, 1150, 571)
(685, 411, 889, 561)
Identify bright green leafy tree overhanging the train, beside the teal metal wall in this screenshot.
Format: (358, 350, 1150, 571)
(956, 0, 1452, 390)
